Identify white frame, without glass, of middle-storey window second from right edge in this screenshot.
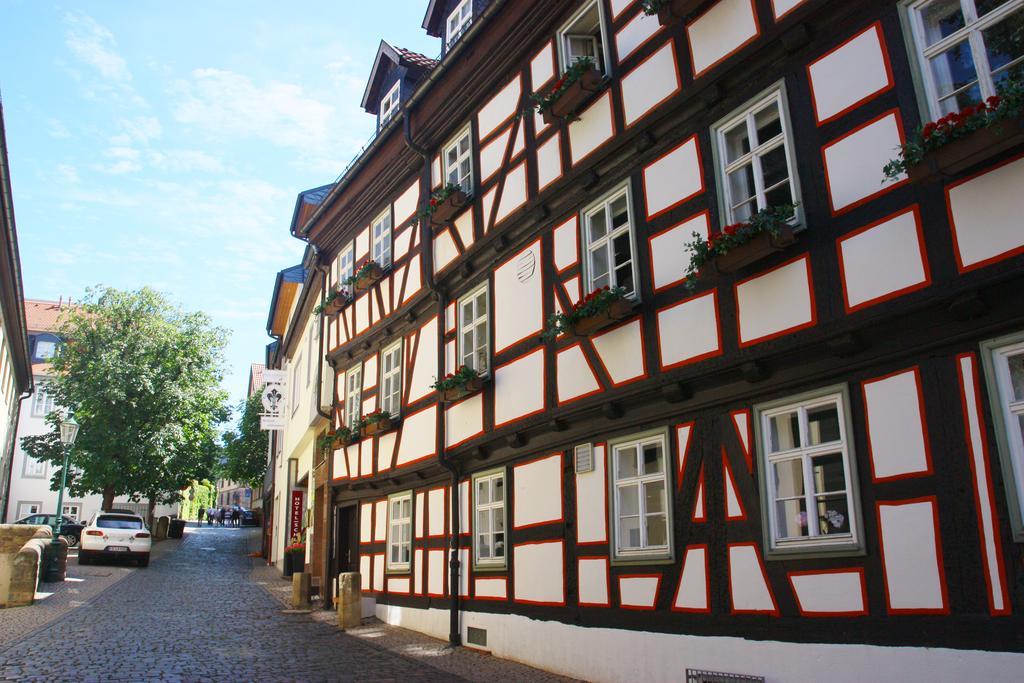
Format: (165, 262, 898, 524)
(711, 82, 803, 225)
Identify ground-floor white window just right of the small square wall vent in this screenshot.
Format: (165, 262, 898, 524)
(610, 432, 672, 560)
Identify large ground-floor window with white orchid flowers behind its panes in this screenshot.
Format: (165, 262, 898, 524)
(757, 387, 860, 555)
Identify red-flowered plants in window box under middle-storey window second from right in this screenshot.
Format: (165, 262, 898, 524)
(686, 204, 797, 290)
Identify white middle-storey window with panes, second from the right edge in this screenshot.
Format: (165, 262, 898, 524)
(712, 85, 800, 224)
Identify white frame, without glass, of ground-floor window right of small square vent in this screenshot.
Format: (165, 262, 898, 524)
(605, 429, 675, 563)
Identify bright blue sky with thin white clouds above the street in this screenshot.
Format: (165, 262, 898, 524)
(0, 0, 440, 411)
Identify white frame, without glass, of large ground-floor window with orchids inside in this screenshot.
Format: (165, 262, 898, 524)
(754, 385, 864, 559)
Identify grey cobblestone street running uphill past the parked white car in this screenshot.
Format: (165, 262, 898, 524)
(0, 527, 560, 681)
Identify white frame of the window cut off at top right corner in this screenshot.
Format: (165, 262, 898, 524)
(902, 0, 1024, 120)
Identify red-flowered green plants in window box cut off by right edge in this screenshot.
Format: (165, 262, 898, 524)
(883, 80, 1024, 182)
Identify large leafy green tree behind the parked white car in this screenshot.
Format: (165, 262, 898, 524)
(22, 288, 228, 510)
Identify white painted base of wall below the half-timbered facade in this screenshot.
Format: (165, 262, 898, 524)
(377, 604, 1024, 683)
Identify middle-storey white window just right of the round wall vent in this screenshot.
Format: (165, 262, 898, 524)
(581, 184, 637, 298)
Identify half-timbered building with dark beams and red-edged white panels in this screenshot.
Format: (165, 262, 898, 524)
(280, 0, 1024, 681)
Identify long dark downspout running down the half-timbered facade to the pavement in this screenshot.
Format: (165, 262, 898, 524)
(402, 105, 462, 647)
